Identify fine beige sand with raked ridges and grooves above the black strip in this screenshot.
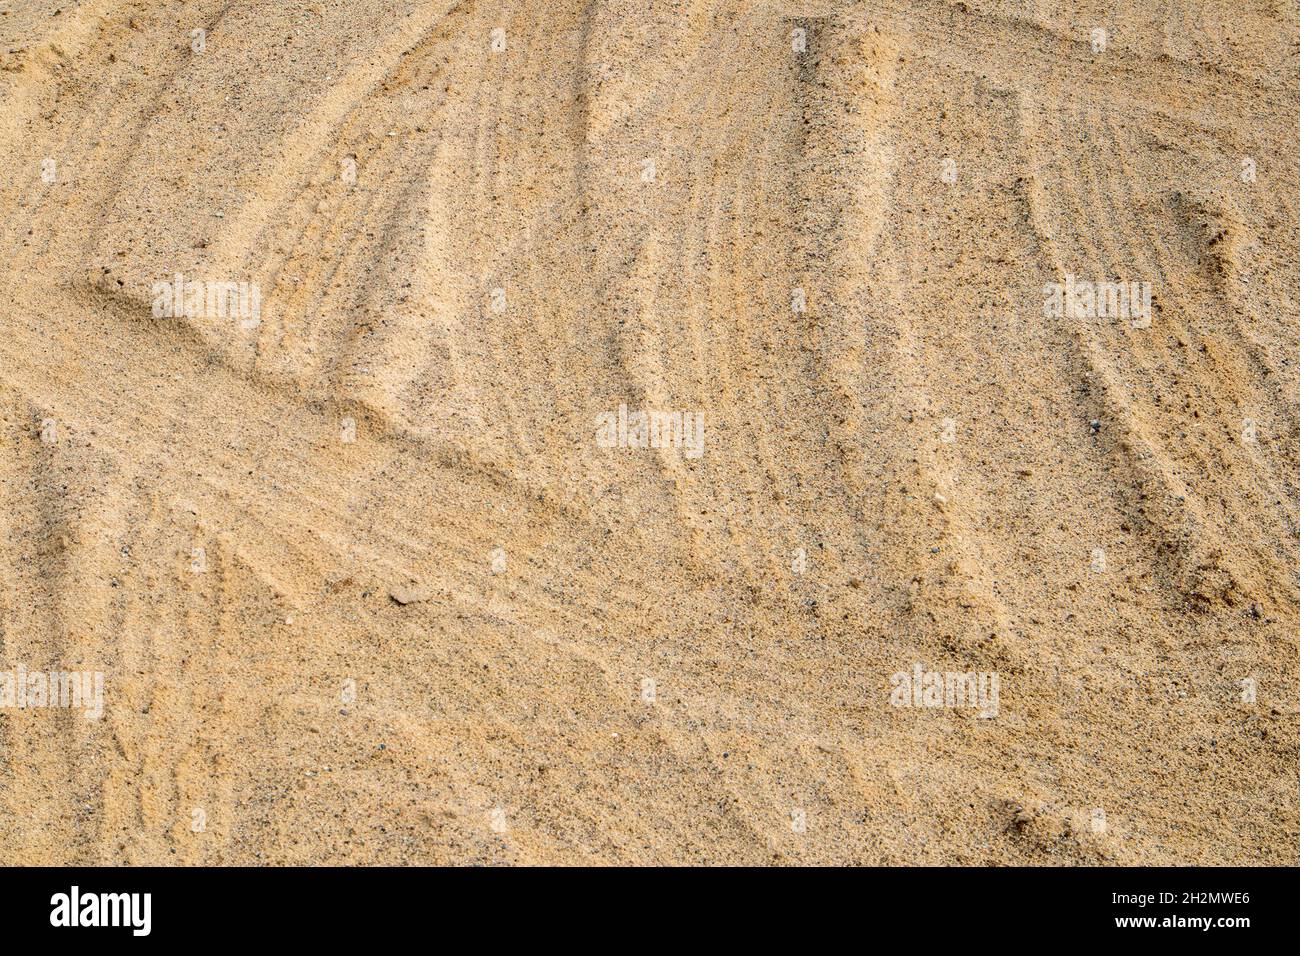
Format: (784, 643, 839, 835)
(0, 0, 1300, 865)
